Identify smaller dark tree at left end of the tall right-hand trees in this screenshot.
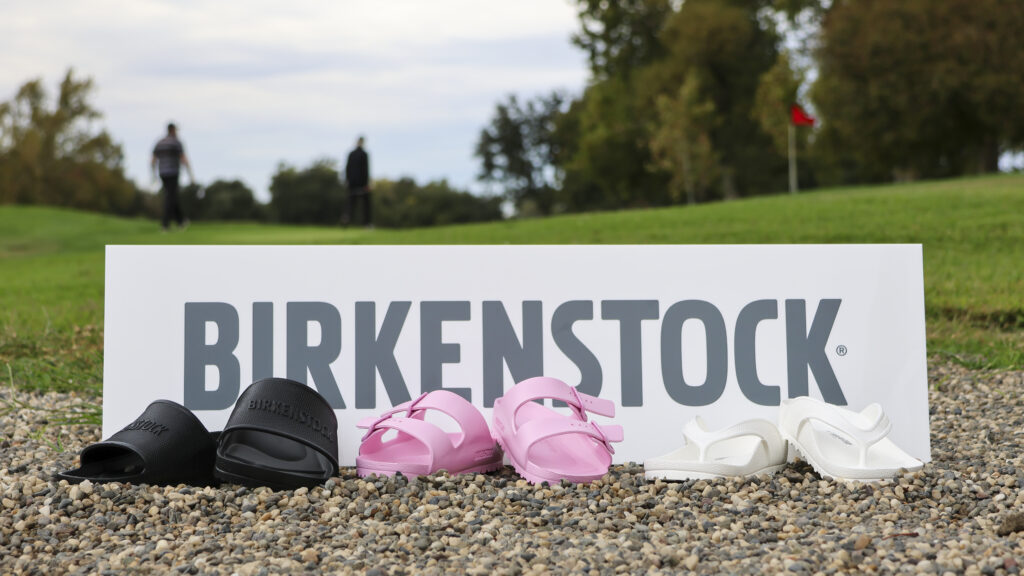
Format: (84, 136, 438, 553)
(475, 91, 565, 214)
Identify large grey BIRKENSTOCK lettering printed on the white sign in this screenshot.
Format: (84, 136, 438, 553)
(183, 298, 847, 410)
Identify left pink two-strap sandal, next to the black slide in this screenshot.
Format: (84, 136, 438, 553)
(355, 390, 502, 478)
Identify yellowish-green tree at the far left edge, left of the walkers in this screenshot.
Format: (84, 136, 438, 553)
(0, 70, 140, 214)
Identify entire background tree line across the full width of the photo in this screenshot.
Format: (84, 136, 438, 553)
(0, 0, 1024, 222)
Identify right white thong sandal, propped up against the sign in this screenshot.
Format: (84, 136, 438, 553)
(778, 397, 925, 482)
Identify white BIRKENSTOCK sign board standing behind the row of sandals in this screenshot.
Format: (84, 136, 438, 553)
(103, 245, 931, 465)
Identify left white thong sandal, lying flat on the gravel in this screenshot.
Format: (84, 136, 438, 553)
(643, 416, 786, 480)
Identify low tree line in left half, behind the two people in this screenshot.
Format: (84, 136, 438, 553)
(0, 71, 503, 228)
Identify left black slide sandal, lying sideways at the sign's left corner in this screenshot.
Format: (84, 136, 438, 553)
(55, 400, 218, 486)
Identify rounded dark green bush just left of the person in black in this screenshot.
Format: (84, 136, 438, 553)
(269, 158, 345, 225)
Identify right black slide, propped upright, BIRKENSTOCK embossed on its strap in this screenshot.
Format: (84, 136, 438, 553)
(213, 378, 338, 490)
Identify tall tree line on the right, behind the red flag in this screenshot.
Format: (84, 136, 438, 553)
(475, 0, 1024, 213)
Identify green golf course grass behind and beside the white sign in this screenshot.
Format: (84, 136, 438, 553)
(0, 171, 1024, 394)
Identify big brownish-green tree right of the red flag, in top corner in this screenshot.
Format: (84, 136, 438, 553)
(811, 0, 1024, 180)
